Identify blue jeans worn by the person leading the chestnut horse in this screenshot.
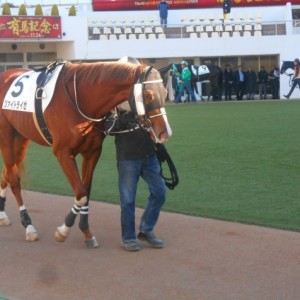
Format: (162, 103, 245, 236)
(118, 155, 166, 241)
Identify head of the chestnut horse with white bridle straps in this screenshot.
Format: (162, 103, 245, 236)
(135, 67, 172, 143)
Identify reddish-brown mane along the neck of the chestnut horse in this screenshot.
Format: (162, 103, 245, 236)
(68, 62, 145, 85)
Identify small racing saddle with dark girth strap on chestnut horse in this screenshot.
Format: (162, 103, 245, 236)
(34, 60, 65, 146)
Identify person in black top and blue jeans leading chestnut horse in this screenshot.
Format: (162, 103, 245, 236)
(115, 58, 166, 251)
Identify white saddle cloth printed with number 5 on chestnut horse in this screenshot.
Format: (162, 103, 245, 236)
(2, 65, 63, 112)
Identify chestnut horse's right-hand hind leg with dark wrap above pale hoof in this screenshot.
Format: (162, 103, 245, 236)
(0, 127, 38, 241)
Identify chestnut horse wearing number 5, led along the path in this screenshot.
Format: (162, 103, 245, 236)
(0, 62, 171, 248)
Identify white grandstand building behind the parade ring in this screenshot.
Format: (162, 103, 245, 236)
(0, 0, 300, 98)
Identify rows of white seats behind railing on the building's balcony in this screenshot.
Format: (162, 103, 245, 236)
(88, 18, 288, 40)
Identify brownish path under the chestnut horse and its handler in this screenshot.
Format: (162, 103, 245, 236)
(0, 191, 300, 300)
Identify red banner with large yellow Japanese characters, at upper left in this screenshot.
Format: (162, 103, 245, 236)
(0, 16, 61, 39)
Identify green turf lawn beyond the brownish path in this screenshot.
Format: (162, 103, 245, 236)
(1, 101, 300, 230)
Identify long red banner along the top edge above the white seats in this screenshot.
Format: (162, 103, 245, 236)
(92, 0, 300, 11)
